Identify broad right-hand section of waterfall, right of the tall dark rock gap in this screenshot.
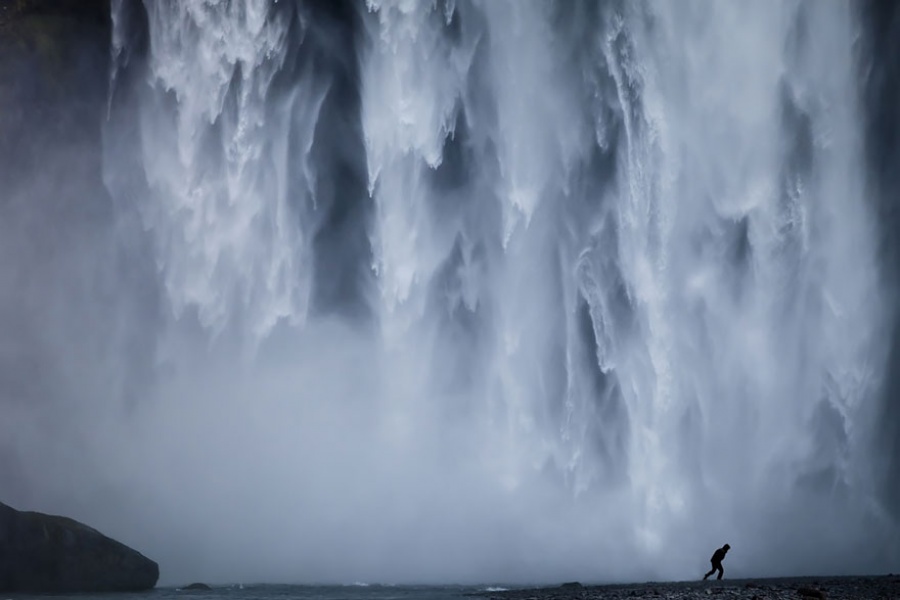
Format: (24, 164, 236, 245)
(363, 2, 883, 564)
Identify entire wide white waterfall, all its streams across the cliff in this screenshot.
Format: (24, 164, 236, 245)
(98, 2, 883, 575)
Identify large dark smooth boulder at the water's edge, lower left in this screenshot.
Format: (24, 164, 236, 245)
(0, 503, 159, 593)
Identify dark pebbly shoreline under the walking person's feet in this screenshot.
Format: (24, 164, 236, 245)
(476, 574, 900, 600)
